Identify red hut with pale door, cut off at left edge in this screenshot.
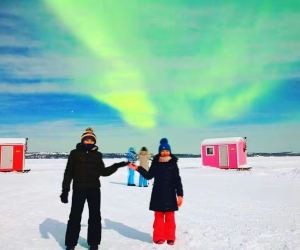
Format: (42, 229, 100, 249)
(0, 138, 27, 172)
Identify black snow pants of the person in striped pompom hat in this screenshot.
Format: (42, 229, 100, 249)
(65, 188, 102, 246)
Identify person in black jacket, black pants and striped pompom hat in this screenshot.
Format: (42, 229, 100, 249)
(60, 128, 128, 250)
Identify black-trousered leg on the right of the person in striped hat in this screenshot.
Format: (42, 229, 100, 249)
(87, 189, 102, 246)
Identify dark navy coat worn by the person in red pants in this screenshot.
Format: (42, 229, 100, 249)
(138, 155, 183, 212)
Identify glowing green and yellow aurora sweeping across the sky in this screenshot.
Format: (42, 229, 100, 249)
(45, 0, 300, 128)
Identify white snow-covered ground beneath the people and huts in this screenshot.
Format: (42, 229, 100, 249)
(0, 157, 300, 250)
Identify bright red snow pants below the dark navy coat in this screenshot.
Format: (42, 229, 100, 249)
(153, 211, 176, 241)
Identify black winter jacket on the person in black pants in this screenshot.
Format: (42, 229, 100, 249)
(62, 143, 118, 191)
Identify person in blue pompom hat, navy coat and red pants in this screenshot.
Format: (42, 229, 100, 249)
(129, 138, 183, 245)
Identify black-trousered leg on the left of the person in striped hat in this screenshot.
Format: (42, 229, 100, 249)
(65, 190, 86, 247)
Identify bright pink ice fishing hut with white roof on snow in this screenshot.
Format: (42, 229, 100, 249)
(201, 137, 248, 169)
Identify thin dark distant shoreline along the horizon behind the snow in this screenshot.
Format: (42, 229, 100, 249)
(25, 152, 300, 159)
